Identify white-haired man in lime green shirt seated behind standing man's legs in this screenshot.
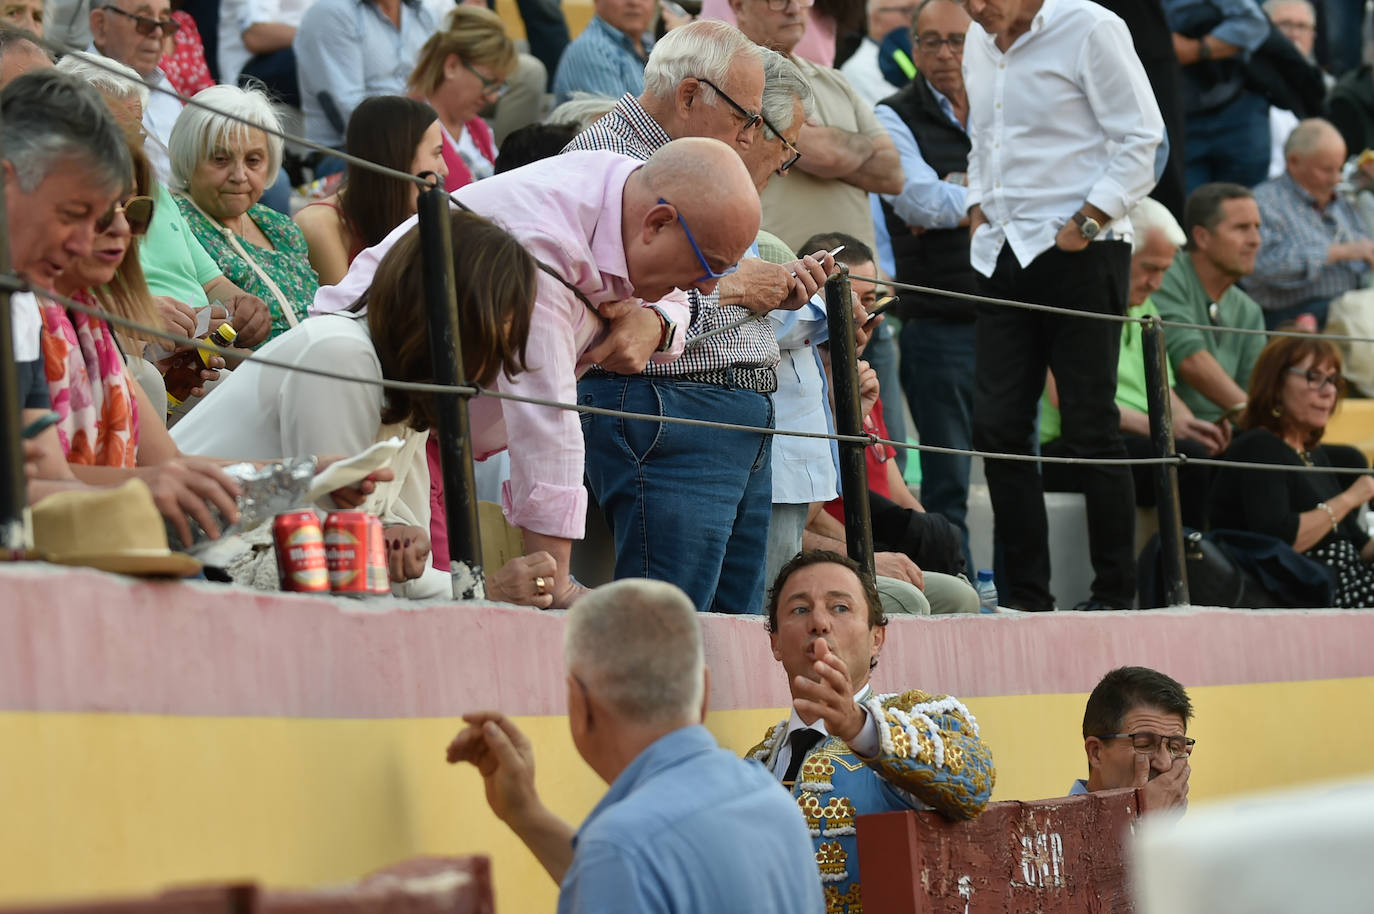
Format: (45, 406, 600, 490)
(1040, 197, 1231, 531)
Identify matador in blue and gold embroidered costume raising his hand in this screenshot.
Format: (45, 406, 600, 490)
(747, 550, 996, 914)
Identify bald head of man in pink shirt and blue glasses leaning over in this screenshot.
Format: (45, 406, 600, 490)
(621, 137, 761, 301)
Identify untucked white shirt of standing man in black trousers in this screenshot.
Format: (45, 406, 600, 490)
(963, 0, 1164, 276)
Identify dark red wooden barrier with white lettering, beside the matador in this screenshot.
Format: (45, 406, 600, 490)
(857, 789, 1139, 914)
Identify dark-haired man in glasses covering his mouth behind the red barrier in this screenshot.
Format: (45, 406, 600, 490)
(1069, 667, 1197, 812)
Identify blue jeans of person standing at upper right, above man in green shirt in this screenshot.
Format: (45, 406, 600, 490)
(1184, 91, 1270, 194)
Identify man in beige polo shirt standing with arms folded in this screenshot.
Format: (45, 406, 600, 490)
(731, 0, 903, 250)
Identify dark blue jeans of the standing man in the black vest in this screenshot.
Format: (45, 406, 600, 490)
(901, 320, 977, 570)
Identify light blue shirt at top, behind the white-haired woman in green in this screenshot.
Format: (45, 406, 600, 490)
(291, 0, 436, 148)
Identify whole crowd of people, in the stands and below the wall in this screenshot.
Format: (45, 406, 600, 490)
(0, 0, 1330, 913)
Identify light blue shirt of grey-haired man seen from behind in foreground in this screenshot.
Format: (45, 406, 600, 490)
(558, 726, 824, 914)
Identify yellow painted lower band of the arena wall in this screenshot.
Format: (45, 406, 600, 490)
(8, 678, 1374, 914)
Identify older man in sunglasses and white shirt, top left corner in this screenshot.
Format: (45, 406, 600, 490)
(91, 0, 181, 184)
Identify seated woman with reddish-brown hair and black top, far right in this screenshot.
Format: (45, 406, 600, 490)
(1210, 335, 1374, 608)
